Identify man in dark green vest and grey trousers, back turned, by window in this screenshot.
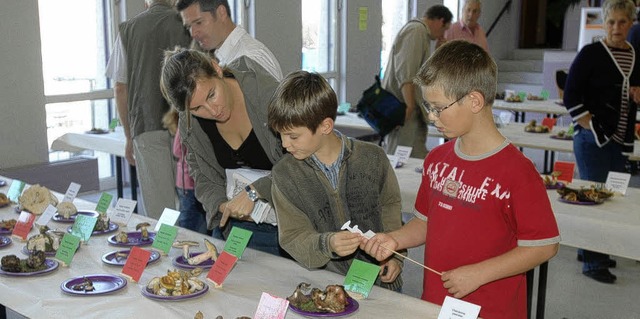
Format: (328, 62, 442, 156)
(107, 0, 191, 219)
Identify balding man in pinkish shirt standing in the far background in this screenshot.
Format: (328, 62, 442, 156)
(444, 0, 489, 52)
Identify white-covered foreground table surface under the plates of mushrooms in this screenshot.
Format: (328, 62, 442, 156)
(0, 180, 440, 319)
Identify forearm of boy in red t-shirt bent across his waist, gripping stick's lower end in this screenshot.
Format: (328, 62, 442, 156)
(441, 243, 558, 298)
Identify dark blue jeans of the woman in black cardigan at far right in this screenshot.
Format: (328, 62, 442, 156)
(573, 129, 626, 272)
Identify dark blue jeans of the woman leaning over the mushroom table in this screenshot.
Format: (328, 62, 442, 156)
(212, 219, 288, 257)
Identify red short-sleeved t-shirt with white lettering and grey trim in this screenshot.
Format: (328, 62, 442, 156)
(415, 140, 560, 319)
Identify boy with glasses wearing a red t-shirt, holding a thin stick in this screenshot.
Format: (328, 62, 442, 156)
(361, 40, 560, 319)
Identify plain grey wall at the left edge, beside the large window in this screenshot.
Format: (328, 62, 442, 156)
(0, 0, 48, 170)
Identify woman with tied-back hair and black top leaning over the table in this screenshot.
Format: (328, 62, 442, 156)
(160, 49, 283, 255)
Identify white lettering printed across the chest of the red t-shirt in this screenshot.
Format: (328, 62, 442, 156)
(423, 162, 511, 203)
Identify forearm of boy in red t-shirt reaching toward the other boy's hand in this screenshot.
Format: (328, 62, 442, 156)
(360, 218, 427, 261)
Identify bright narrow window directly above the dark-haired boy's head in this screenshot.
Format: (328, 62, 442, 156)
(302, 0, 339, 92)
